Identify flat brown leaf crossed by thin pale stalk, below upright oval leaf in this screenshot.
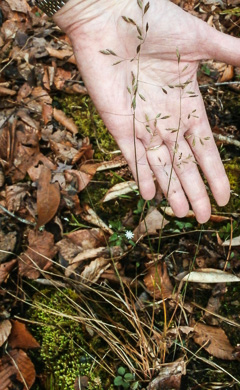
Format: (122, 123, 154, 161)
(18, 230, 57, 279)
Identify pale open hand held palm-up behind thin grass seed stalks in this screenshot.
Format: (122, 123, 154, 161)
(54, 0, 240, 223)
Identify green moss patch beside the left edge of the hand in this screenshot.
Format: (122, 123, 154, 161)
(55, 95, 118, 160)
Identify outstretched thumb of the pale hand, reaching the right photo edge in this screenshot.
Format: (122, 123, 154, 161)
(202, 25, 240, 66)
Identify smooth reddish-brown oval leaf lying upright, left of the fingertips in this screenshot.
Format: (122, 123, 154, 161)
(37, 165, 60, 227)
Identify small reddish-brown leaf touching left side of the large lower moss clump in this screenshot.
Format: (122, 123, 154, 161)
(8, 320, 40, 349)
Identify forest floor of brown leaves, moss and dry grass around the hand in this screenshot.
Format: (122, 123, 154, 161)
(0, 0, 240, 390)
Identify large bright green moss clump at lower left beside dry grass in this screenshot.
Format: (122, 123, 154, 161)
(28, 289, 105, 390)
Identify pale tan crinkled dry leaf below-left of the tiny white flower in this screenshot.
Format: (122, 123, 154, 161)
(80, 257, 110, 285)
